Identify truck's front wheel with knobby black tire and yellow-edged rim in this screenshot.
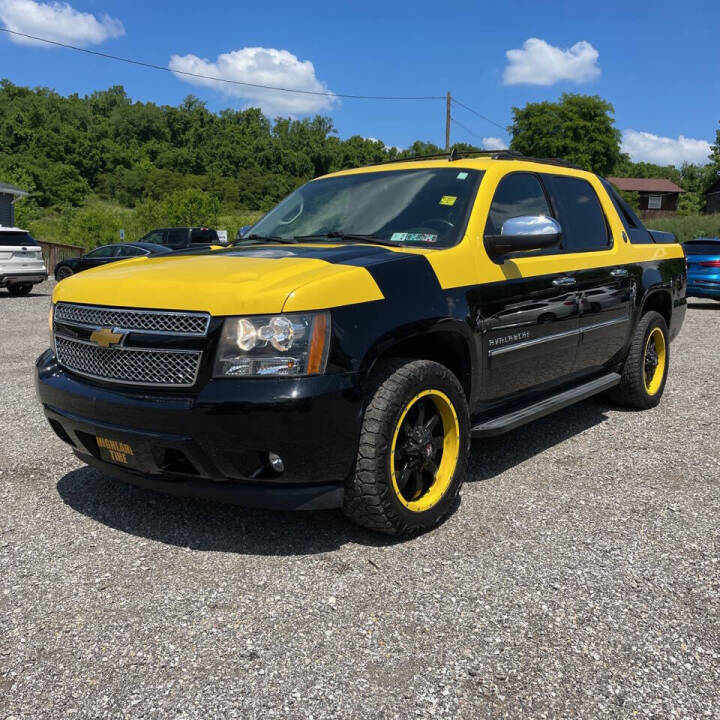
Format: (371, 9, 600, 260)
(343, 360, 470, 536)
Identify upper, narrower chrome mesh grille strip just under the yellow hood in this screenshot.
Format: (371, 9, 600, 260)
(55, 303, 210, 336)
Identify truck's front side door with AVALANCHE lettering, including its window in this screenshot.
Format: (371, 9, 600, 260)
(473, 173, 579, 402)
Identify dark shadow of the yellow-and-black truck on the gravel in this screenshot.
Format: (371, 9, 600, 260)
(57, 399, 611, 556)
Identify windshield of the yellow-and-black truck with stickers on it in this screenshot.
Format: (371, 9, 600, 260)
(249, 167, 482, 247)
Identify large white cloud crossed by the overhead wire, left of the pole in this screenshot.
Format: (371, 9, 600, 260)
(168, 48, 337, 116)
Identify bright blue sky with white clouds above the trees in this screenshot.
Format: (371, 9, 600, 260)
(0, 0, 720, 163)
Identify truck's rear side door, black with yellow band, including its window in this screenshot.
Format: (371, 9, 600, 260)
(543, 175, 633, 371)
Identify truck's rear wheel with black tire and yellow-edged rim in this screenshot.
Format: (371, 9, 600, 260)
(610, 310, 670, 410)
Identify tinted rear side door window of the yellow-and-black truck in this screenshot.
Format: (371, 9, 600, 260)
(545, 175, 610, 252)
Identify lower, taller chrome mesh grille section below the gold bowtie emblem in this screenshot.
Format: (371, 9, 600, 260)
(55, 335, 202, 387)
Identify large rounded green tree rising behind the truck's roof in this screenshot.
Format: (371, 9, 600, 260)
(510, 93, 620, 175)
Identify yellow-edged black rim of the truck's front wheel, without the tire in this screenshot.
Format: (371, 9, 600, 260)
(389, 390, 460, 512)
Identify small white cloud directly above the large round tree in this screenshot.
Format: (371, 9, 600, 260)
(503, 38, 600, 85)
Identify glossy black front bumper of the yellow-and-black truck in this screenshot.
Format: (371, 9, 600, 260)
(36, 350, 362, 509)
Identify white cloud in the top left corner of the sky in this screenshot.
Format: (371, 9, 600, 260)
(0, 0, 125, 47)
